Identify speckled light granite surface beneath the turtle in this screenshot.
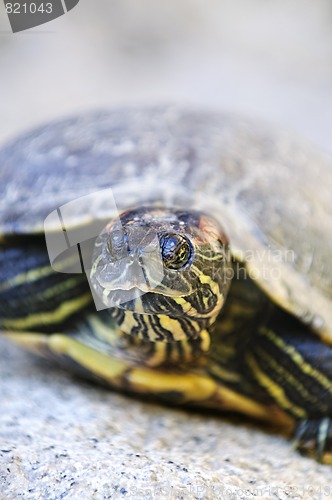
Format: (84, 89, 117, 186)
(0, 338, 332, 500)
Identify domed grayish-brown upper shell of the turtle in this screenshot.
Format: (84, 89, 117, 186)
(0, 106, 332, 343)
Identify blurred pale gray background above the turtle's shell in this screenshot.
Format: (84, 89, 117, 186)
(0, 0, 332, 152)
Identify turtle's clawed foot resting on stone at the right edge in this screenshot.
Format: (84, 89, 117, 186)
(294, 417, 332, 464)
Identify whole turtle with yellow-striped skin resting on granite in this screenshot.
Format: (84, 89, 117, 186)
(0, 105, 332, 464)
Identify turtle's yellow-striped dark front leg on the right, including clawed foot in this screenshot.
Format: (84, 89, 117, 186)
(245, 310, 332, 464)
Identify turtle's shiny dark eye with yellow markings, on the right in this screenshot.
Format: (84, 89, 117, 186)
(160, 233, 193, 269)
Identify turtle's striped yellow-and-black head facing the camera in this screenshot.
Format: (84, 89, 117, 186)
(91, 207, 229, 342)
